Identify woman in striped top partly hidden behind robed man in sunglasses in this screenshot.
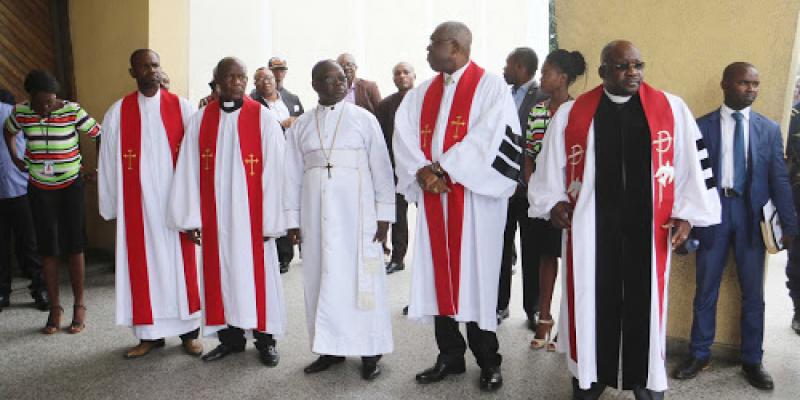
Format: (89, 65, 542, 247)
(525, 49, 586, 351)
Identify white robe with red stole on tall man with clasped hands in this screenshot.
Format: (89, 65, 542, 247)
(393, 62, 521, 331)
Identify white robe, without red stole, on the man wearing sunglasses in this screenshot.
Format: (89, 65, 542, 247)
(528, 88, 720, 391)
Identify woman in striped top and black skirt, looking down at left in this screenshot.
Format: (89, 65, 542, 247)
(5, 71, 100, 334)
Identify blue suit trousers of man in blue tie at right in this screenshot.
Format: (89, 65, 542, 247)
(690, 196, 764, 364)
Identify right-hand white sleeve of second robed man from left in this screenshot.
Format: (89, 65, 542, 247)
(261, 107, 286, 238)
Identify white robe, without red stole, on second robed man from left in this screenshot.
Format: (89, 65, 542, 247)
(168, 102, 286, 336)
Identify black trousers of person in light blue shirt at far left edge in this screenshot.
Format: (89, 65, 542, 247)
(0, 195, 44, 295)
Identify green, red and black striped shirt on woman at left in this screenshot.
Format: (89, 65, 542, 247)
(5, 101, 100, 189)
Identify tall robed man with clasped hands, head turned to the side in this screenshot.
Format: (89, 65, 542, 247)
(393, 22, 521, 390)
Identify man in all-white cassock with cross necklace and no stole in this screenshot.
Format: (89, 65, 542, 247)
(284, 60, 395, 380)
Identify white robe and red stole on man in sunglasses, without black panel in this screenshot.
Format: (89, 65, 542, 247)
(528, 84, 720, 391)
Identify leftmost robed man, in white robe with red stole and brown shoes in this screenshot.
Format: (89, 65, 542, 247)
(98, 49, 203, 358)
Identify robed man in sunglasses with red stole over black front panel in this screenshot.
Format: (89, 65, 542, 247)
(528, 41, 720, 400)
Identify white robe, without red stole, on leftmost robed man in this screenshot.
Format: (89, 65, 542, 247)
(97, 92, 200, 340)
